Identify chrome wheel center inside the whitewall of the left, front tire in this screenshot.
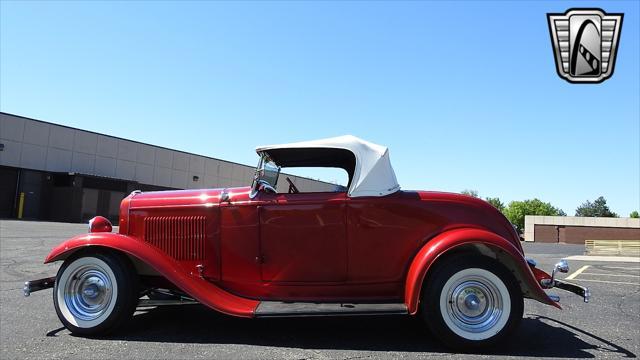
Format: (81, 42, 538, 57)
(64, 265, 113, 321)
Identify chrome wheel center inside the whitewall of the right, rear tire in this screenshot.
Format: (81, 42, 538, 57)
(446, 276, 503, 333)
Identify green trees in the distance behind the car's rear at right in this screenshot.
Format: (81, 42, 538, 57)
(462, 190, 640, 231)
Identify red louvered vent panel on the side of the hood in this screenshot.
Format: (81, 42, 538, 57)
(144, 216, 206, 260)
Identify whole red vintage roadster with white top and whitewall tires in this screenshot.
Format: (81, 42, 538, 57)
(24, 136, 589, 349)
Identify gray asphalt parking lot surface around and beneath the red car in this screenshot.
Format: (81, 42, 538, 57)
(0, 221, 640, 359)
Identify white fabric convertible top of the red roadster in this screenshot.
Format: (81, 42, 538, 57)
(256, 135, 400, 197)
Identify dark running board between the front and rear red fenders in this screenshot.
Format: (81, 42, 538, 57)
(255, 301, 408, 317)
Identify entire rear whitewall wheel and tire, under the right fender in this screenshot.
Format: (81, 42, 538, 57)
(420, 255, 524, 350)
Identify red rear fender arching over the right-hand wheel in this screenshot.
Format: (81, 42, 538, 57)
(405, 229, 560, 314)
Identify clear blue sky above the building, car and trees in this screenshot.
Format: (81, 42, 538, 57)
(0, 1, 640, 216)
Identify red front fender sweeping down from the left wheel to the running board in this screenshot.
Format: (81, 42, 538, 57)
(45, 233, 259, 317)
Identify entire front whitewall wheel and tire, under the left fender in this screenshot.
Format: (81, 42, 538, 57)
(53, 252, 138, 336)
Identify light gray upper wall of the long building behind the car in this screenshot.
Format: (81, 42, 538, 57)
(0, 113, 334, 191)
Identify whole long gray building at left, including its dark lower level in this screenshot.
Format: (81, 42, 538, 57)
(0, 113, 335, 222)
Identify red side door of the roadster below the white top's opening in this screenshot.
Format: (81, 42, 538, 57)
(258, 193, 347, 283)
